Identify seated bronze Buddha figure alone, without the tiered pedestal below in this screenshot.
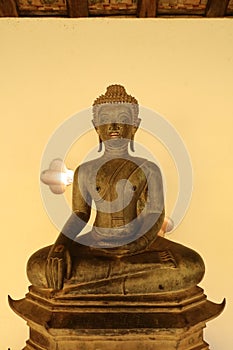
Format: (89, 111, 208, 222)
(27, 85, 204, 295)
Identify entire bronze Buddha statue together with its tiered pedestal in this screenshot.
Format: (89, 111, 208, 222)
(9, 85, 225, 350)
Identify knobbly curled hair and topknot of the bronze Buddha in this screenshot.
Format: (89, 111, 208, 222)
(92, 84, 139, 124)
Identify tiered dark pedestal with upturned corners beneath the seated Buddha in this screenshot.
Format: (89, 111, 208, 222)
(9, 287, 225, 350)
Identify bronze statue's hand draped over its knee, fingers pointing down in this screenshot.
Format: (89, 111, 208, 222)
(45, 244, 71, 290)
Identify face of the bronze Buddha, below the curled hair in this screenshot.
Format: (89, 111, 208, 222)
(95, 104, 137, 142)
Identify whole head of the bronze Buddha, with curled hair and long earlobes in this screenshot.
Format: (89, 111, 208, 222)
(93, 84, 140, 151)
